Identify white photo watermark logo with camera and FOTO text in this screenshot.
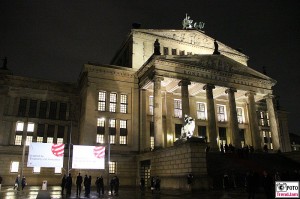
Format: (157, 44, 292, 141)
(275, 181, 299, 198)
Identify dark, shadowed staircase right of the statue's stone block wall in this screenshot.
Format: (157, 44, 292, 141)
(206, 152, 300, 189)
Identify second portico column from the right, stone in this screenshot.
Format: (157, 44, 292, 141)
(246, 91, 262, 149)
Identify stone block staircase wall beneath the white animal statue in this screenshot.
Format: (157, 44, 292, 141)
(138, 141, 210, 190)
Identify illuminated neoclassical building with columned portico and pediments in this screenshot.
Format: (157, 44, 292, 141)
(0, 29, 291, 188)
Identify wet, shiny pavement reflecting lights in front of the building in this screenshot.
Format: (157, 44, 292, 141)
(0, 186, 265, 199)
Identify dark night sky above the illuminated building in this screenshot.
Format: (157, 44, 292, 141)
(0, 0, 300, 134)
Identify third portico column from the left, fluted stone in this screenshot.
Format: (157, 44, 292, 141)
(203, 84, 218, 149)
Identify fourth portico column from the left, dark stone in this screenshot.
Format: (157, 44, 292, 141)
(225, 88, 242, 148)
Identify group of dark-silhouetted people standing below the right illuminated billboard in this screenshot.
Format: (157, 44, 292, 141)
(61, 173, 119, 197)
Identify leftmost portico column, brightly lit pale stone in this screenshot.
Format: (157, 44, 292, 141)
(153, 76, 164, 149)
